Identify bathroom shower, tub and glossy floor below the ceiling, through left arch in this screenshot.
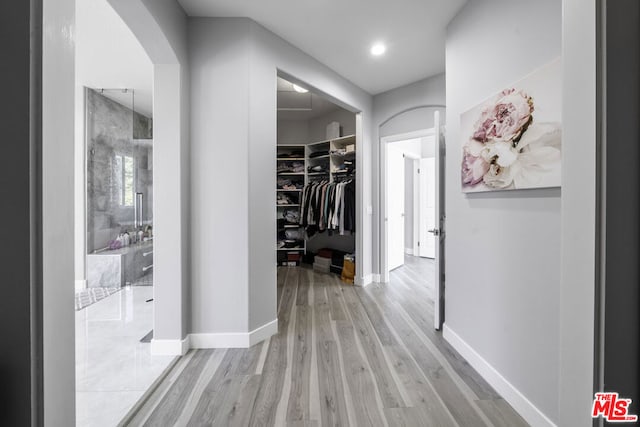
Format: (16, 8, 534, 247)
(75, 88, 173, 426)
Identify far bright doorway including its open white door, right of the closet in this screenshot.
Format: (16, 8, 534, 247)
(380, 111, 445, 330)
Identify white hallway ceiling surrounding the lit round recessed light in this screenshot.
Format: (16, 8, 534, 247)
(178, 0, 467, 95)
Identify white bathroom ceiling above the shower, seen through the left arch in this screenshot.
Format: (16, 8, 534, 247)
(76, 0, 153, 117)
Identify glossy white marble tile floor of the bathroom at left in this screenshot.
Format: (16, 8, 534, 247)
(76, 286, 173, 427)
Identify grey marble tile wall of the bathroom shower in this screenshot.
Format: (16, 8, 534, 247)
(86, 89, 153, 253)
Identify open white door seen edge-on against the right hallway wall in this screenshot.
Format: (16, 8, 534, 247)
(430, 111, 445, 330)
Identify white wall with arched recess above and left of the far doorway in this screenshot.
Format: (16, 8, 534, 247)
(372, 74, 446, 274)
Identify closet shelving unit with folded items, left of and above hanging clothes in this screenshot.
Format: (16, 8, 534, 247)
(276, 135, 356, 266)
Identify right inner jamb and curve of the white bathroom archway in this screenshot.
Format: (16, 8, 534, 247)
(108, 0, 190, 348)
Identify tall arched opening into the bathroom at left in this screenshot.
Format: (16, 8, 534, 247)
(75, 0, 174, 426)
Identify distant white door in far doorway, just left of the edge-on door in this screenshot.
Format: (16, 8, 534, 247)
(418, 157, 436, 258)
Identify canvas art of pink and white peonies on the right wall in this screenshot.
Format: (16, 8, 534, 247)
(461, 60, 562, 193)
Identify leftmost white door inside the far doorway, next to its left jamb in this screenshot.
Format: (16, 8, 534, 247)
(387, 144, 404, 271)
